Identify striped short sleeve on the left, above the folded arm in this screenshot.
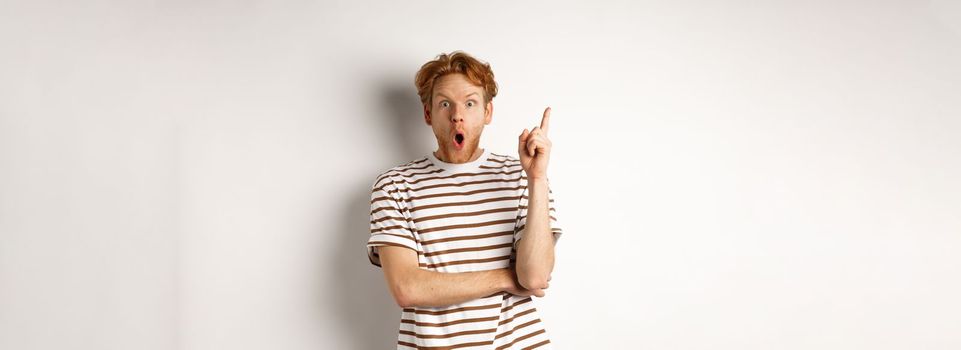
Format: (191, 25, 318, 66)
(367, 178, 419, 266)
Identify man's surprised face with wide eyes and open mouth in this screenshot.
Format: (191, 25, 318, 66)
(424, 74, 494, 163)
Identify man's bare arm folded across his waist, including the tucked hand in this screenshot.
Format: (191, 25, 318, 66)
(379, 246, 544, 307)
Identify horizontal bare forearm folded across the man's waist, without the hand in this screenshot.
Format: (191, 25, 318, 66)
(405, 269, 514, 307)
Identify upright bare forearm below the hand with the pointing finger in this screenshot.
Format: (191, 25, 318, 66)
(516, 179, 554, 289)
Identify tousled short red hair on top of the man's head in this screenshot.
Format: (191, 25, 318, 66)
(414, 51, 497, 107)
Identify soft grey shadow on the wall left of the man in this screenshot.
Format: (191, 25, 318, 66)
(319, 79, 433, 349)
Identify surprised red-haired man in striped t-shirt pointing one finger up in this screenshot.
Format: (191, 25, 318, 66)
(367, 52, 562, 349)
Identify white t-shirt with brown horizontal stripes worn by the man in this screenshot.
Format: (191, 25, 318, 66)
(367, 150, 562, 349)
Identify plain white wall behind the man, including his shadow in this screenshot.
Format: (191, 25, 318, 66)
(0, 0, 961, 350)
